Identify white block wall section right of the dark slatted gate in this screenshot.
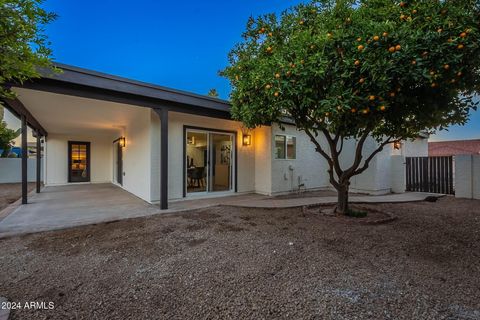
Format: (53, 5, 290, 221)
(455, 155, 480, 199)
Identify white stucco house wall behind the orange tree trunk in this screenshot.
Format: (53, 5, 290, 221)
(268, 125, 422, 194)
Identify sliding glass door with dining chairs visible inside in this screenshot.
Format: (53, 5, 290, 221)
(185, 129, 235, 194)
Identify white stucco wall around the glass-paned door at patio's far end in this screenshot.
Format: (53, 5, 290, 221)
(45, 134, 113, 186)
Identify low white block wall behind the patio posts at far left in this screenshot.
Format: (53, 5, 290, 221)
(0, 158, 43, 183)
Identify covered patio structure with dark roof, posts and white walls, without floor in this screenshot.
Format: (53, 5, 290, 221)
(3, 64, 230, 210)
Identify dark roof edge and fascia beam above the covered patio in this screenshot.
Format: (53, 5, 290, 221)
(18, 64, 231, 119)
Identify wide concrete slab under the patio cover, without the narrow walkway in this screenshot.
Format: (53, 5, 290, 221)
(0, 183, 160, 237)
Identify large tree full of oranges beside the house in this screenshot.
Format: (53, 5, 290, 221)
(221, 0, 480, 214)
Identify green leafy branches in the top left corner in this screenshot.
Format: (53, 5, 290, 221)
(0, 0, 56, 98)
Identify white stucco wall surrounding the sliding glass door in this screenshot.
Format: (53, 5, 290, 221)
(150, 112, 255, 202)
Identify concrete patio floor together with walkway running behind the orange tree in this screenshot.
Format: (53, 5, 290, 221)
(0, 184, 439, 238)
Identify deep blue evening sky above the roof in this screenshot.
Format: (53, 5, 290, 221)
(43, 0, 480, 140)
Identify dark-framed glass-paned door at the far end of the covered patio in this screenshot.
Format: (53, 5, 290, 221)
(68, 141, 90, 182)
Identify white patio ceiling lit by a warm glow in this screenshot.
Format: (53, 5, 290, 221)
(15, 88, 148, 137)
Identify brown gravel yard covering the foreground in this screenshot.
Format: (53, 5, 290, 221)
(0, 197, 480, 319)
